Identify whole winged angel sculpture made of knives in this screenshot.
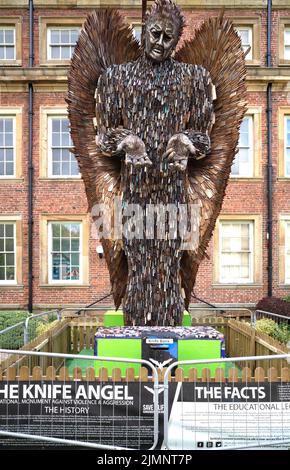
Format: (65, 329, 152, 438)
(67, 0, 246, 326)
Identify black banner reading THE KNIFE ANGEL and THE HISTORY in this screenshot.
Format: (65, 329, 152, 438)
(0, 381, 154, 449)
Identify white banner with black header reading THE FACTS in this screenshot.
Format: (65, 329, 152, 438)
(168, 382, 290, 450)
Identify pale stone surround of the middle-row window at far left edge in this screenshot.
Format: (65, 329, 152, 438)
(0, 106, 23, 184)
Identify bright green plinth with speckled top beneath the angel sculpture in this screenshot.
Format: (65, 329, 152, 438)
(94, 326, 224, 376)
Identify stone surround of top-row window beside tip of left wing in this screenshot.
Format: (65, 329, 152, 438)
(39, 16, 85, 67)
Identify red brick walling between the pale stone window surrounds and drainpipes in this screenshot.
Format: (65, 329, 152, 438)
(0, 8, 290, 307)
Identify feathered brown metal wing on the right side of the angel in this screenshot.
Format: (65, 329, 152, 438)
(175, 13, 246, 308)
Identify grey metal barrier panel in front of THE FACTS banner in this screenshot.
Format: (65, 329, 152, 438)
(164, 354, 290, 450)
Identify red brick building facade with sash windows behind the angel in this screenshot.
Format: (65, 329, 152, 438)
(0, 0, 290, 314)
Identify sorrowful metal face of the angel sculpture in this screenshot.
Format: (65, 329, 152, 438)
(145, 18, 178, 62)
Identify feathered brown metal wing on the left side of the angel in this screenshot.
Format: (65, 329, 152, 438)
(66, 10, 140, 307)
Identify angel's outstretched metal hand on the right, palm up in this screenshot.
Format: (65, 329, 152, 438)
(163, 134, 196, 171)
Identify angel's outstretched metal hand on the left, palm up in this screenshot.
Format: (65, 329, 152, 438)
(117, 135, 152, 167)
